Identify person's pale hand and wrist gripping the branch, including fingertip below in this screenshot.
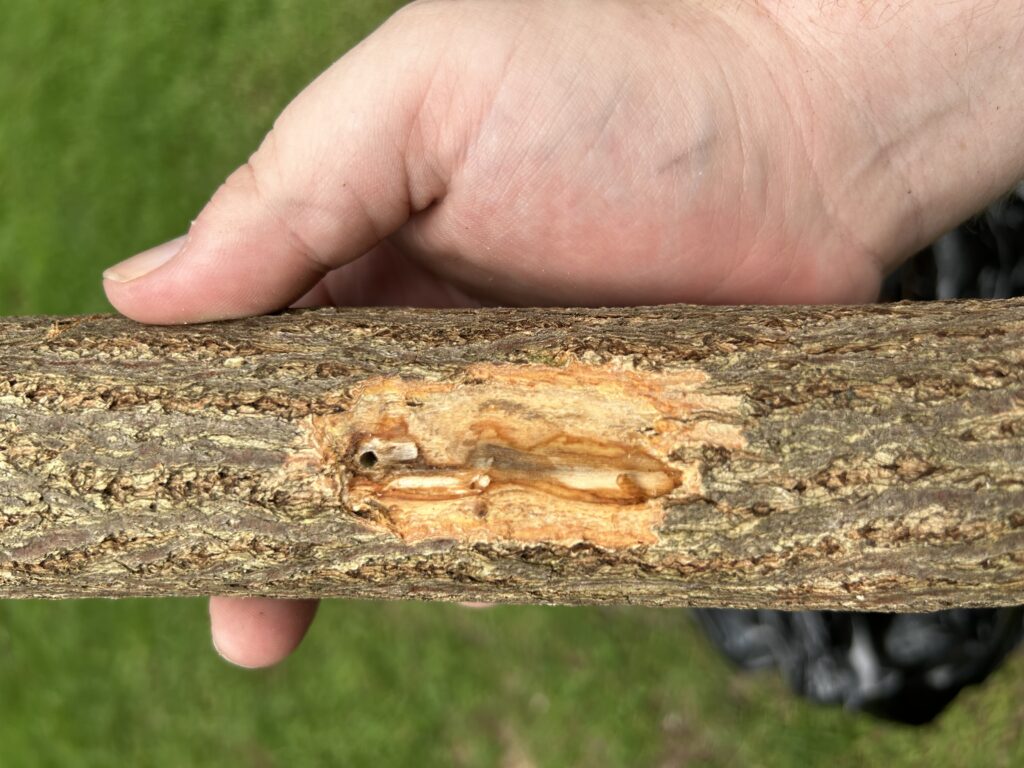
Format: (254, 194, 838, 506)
(104, 0, 1024, 667)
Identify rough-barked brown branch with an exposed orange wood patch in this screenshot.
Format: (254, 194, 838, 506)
(0, 300, 1024, 610)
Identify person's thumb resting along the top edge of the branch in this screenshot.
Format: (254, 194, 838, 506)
(103, 7, 444, 324)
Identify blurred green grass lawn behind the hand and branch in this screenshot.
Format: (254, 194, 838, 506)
(0, 0, 1024, 768)
